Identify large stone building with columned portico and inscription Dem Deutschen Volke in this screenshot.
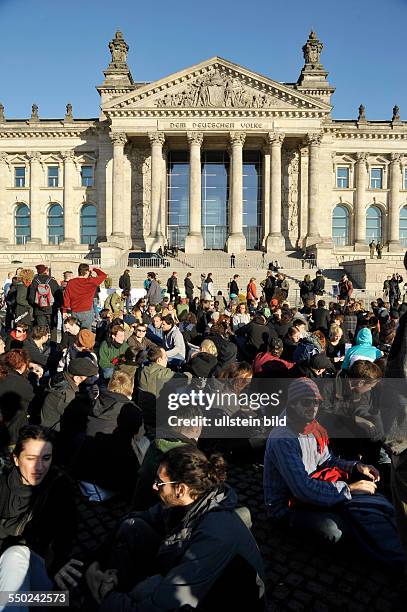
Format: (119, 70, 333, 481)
(0, 32, 407, 264)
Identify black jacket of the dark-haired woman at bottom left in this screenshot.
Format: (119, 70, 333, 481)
(0, 467, 77, 578)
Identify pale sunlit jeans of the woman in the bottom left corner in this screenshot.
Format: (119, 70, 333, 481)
(0, 546, 53, 612)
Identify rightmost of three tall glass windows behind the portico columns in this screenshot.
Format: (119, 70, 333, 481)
(243, 151, 263, 250)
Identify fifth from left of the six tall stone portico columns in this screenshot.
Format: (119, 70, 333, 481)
(266, 133, 285, 253)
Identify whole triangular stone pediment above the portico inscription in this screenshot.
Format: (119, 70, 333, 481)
(102, 57, 331, 117)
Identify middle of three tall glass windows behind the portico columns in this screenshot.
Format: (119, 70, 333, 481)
(201, 151, 229, 250)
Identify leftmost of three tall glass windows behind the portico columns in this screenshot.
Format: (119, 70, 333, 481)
(167, 151, 189, 249)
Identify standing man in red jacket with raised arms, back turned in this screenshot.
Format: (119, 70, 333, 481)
(64, 263, 107, 329)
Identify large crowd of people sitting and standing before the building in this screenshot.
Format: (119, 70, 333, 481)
(0, 258, 407, 612)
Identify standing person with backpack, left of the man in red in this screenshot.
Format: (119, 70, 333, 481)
(27, 264, 62, 340)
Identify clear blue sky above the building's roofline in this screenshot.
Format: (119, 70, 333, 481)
(0, 0, 407, 120)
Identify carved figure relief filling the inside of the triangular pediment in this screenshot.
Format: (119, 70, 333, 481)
(154, 68, 292, 108)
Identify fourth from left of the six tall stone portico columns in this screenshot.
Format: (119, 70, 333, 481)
(226, 132, 246, 254)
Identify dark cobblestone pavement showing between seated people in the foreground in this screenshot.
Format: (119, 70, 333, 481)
(74, 463, 407, 612)
